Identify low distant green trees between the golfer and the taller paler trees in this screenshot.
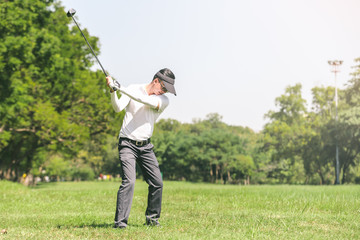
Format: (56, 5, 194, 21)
(152, 113, 255, 183)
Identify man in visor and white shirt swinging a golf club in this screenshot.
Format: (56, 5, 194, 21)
(106, 68, 176, 228)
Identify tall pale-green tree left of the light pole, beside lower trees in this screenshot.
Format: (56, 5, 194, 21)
(263, 84, 307, 183)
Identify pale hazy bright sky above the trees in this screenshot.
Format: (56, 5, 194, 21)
(61, 0, 360, 131)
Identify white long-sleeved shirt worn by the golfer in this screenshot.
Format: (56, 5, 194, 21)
(111, 84, 169, 141)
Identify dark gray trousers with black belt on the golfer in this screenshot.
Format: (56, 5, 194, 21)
(115, 139, 163, 227)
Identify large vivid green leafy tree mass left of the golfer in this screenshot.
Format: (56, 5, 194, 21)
(0, 0, 123, 180)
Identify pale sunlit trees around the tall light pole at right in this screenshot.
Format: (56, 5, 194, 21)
(263, 59, 360, 184)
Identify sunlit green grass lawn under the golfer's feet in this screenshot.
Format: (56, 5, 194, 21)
(0, 180, 360, 239)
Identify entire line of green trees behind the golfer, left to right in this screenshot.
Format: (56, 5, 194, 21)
(0, 0, 360, 184)
